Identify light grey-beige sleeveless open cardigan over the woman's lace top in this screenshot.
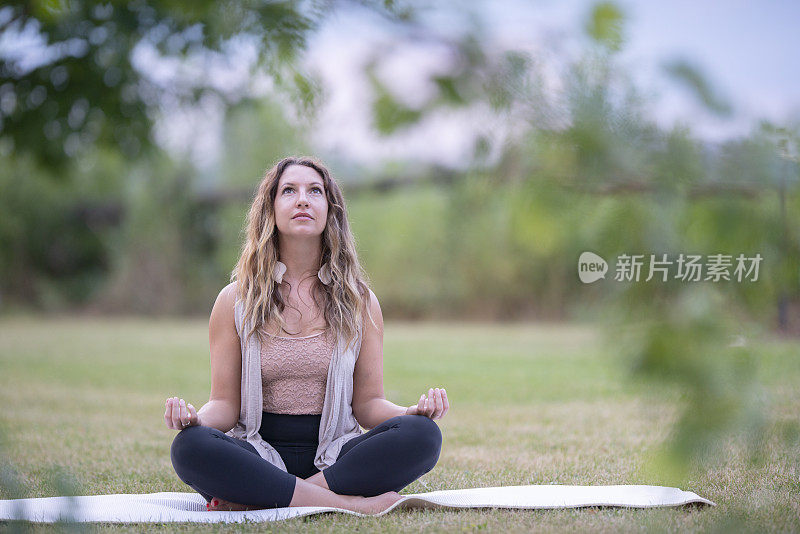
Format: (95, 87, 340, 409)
(226, 278, 362, 471)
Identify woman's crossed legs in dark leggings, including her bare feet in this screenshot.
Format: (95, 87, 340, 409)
(170, 415, 442, 513)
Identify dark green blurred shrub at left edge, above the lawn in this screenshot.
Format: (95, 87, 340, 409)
(0, 153, 114, 308)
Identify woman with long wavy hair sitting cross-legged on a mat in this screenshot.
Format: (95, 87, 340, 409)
(164, 157, 449, 513)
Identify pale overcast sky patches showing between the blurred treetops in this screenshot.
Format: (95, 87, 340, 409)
(300, 0, 800, 170)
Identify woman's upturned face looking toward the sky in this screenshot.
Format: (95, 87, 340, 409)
(275, 165, 328, 237)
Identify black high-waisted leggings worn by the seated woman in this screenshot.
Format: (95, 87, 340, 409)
(170, 412, 442, 508)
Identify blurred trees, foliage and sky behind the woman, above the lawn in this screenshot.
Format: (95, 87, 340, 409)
(0, 0, 800, 528)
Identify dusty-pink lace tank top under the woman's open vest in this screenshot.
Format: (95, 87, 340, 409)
(261, 330, 333, 415)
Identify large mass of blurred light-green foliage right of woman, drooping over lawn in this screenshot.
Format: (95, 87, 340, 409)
(358, 0, 800, 492)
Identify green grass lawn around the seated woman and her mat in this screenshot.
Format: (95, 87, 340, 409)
(0, 318, 800, 532)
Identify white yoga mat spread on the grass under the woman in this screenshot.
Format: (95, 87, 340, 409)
(0, 485, 716, 523)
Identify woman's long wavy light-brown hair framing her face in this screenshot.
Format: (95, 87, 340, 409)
(231, 156, 375, 352)
